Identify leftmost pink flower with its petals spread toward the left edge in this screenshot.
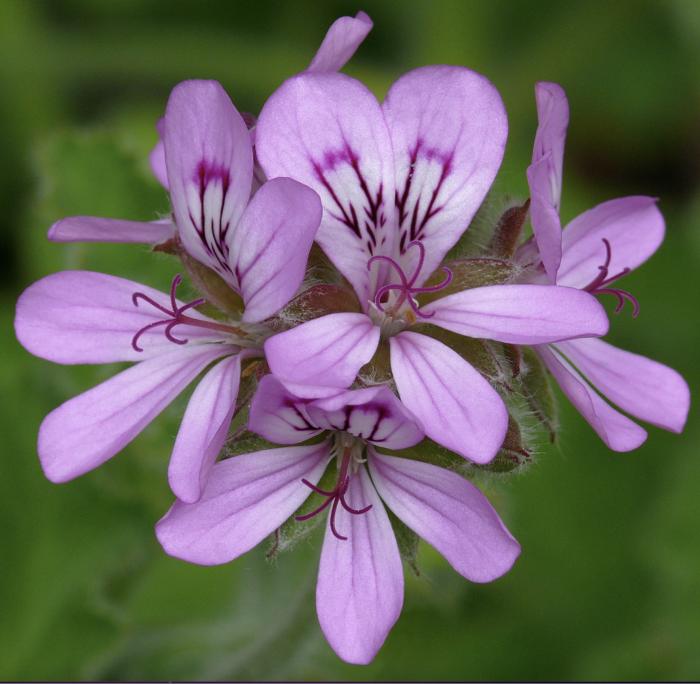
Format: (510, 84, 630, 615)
(15, 81, 321, 501)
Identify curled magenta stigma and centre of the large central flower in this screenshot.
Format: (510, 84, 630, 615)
(367, 240, 452, 323)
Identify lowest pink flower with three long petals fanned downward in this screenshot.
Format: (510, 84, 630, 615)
(156, 375, 520, 664)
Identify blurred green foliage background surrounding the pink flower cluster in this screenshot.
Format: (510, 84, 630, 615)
(0, 0, 700, 680)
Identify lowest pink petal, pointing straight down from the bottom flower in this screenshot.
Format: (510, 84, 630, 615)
(316, 468, 403, 665)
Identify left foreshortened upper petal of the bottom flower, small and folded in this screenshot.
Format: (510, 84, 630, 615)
(248, 375, 321, 444)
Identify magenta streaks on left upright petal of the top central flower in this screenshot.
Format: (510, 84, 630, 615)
(310, 142, 386, 254)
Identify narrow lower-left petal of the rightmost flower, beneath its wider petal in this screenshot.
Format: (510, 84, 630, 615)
(537, 346, 647, 451)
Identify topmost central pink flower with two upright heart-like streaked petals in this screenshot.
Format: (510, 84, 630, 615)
(256, 66, 608, 463)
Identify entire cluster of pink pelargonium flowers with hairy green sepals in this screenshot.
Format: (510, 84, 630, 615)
(15, 13, 689, 663)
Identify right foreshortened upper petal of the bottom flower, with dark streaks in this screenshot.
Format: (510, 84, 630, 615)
(307, 386, 424, 449)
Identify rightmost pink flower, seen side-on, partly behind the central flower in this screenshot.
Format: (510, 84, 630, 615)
(518, 83, 690, 451)
